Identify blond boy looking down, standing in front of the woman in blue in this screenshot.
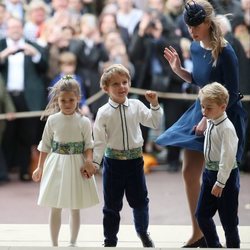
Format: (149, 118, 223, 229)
(196, 82, 240, 248)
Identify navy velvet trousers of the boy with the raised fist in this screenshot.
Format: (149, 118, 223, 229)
(103, 157, 149, 245)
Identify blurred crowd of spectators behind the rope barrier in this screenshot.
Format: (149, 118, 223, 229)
(0, 0, 250, 183)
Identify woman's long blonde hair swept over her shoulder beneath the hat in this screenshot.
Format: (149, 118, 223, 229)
(187, 0, 227, 65)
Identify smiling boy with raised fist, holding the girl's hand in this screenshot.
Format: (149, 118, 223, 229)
(93, 64, 163, 247)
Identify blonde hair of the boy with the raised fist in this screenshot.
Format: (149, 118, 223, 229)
(100, 64, 131, 89)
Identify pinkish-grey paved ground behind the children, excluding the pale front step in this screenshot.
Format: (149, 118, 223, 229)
(0, 166, 250, 225)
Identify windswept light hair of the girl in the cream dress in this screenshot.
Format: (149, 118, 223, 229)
(41, 75, 81, 120)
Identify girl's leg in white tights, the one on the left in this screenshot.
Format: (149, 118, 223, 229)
(49, 208, 62, 247)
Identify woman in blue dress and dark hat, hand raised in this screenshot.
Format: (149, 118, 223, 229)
(156, 0, 246, 247)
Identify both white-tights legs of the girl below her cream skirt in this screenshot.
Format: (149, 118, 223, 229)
(49, 208, 80, 246)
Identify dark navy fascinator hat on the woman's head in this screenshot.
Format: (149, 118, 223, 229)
(184, 1, 206, 26)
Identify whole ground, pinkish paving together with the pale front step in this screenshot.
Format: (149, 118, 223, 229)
(0, 166, 250, 250)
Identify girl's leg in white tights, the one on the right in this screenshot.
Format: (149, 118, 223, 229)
(69, 209, 80, 245)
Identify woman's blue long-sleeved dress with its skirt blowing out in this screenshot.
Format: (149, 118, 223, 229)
(156, 42, 247, 162)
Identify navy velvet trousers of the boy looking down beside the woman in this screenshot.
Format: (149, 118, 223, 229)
(196, 168, 240, 248)
